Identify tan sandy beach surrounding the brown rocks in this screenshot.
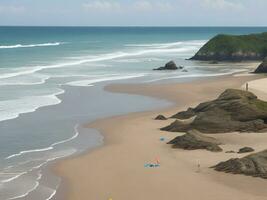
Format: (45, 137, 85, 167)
(54, 76, 267, 200)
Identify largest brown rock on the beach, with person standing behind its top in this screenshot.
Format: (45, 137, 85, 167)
(162, 89, 267, 133)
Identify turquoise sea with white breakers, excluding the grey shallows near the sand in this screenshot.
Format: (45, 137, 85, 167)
(0, 27, 267, 120)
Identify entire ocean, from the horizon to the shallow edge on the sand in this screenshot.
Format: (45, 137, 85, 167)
(0, 27, 267, 200)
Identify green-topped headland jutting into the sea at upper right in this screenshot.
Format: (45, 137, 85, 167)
(191, 33, 267, 61)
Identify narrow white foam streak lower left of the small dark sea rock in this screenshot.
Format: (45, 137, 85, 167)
(66, 74, 145, 87)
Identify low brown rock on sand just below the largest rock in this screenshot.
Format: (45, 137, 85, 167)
(168, 131, 222, 152)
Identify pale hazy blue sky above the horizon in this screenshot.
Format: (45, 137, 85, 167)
(0, 0, 267, 26)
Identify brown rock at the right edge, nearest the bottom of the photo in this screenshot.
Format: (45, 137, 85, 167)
(215, 150, 267, 179)
